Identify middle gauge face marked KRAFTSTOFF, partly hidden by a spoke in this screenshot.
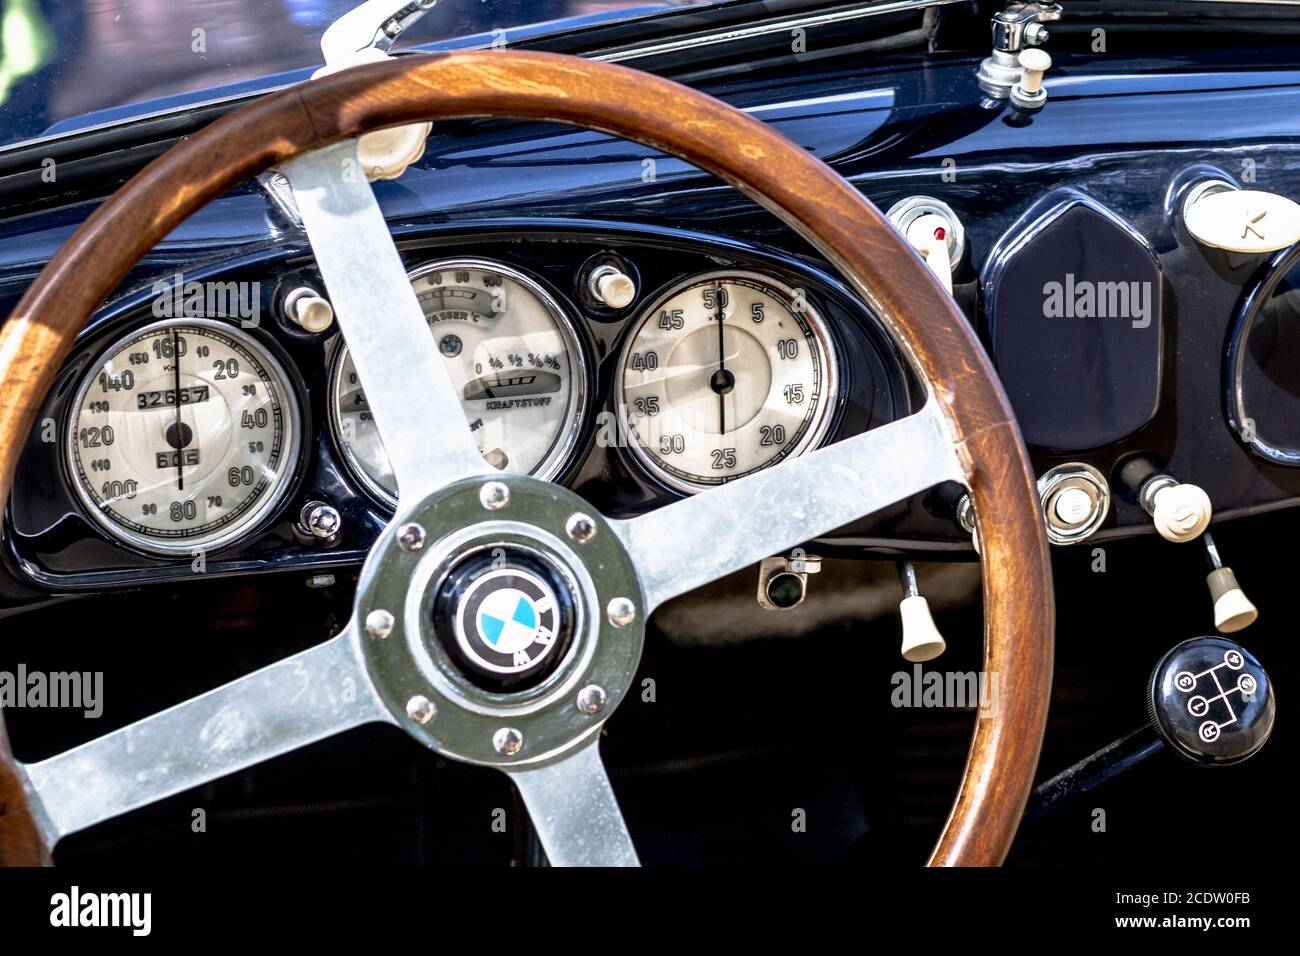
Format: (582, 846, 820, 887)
(330, 259, 586, 505)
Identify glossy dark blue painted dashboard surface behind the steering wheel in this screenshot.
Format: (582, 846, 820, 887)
(0, 47, 1300, 598)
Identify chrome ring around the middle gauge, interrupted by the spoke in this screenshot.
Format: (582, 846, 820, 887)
(325, 258, 590, 510)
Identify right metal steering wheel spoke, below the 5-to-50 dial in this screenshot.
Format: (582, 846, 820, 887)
(611, 399, 966, 615)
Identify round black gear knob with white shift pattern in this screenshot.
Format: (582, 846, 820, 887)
(1148, 637, 1275, 766)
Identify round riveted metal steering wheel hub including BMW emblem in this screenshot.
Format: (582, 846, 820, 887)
(356, 476, 644, 766)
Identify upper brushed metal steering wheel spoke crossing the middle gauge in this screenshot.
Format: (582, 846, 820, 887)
(281, 139, 494, 502)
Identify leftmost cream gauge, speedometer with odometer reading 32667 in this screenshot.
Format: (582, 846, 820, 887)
(64, 319, 302, 554)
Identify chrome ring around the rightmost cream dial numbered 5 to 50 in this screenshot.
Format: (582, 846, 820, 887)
(614, 269, 840, 494)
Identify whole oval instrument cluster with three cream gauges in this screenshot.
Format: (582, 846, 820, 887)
(5, 237, 907, 588)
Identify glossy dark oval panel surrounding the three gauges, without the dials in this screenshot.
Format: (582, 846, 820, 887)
(7, 230, 909, 589)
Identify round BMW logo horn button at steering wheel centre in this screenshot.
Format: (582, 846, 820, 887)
(433, 546, 576, 691)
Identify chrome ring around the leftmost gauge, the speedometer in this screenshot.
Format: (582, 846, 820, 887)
(60, 316, 306, 557)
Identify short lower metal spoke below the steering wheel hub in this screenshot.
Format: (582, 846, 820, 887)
(506, 734, 641, 866)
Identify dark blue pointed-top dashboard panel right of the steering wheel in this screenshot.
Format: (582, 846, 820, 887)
(982, 189, 1164, 453)
